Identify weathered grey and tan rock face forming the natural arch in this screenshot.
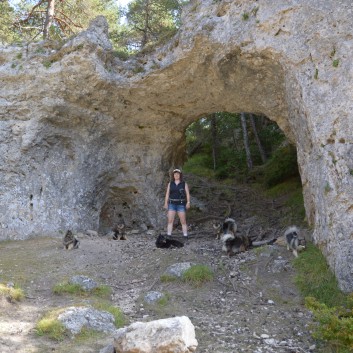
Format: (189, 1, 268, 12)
(0, 0, 353, 291)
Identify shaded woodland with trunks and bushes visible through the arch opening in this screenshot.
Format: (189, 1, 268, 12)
(180, 112, 305, 224)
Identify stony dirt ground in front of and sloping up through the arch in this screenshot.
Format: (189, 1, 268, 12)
(0, 176, 318, 353)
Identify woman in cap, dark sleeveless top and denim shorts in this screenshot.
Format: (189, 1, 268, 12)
(164, 169, 190, 237)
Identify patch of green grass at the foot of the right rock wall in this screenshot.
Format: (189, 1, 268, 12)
(294, 243, 346, 307)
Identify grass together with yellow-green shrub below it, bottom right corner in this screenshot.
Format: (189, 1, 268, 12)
(294, 243, 353, 353)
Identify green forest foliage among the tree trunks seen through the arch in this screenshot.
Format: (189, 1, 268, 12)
(185, 112, 285, 180)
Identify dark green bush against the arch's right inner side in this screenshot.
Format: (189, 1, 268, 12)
(264, 144, 299, 187)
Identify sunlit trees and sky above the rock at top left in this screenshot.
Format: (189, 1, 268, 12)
(0, 0, 188, 53)
